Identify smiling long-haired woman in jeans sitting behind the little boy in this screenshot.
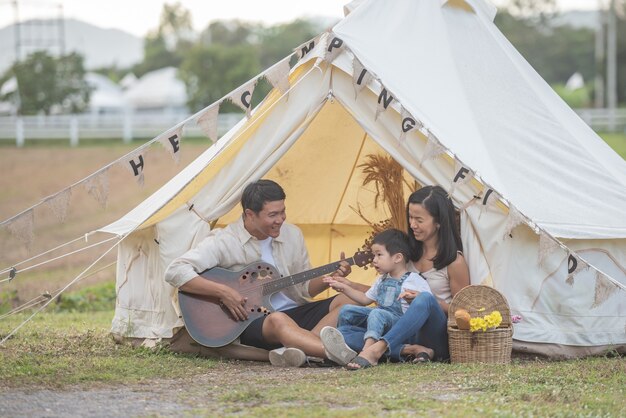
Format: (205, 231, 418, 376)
(341, 186, 469, 369)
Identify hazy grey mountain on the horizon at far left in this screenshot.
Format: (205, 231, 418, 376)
(0, 19, 143, 74)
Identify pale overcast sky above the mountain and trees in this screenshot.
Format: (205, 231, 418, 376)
(0, 0, 599, 36)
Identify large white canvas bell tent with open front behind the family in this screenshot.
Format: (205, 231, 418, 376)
(102, 0, 626, 356)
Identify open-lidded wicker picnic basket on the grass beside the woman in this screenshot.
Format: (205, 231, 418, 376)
(448, 285, 513, 363)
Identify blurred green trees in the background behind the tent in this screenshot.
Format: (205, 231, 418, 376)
(0, 0, 626, 114)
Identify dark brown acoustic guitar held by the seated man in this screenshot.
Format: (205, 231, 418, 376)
(178, 251, 373, 347)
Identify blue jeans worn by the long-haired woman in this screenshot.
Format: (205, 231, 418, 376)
(337, 292, 450, 361)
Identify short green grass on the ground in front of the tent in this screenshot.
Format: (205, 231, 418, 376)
(0, 311, 626, 417)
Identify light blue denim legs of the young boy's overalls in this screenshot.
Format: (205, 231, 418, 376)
(337, 305, 400, 341)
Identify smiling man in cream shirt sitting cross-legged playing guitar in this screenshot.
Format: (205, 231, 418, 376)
(165, 180, 366, 366)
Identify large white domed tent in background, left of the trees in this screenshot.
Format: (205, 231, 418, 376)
(124, 67, 187, 115)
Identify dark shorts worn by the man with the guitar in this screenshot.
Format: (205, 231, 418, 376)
(239, 296, 335, 350)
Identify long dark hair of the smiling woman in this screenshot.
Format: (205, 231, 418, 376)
(406, 186, 463, 270)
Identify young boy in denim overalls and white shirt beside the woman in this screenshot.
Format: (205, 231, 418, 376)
(320, 229, 431, 366)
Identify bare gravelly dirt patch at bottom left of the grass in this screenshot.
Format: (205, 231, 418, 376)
(0, 361, 346, 418)
